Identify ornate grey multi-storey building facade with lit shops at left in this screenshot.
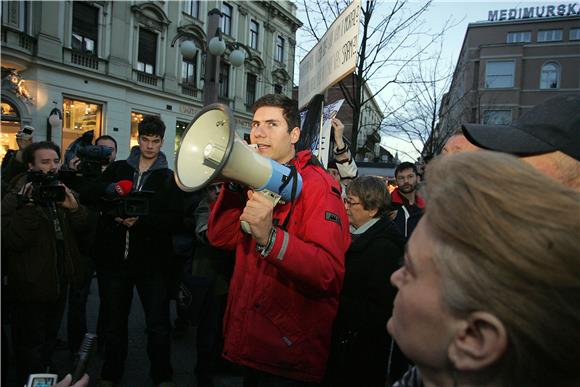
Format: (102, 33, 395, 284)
(0, 0, 301, 165)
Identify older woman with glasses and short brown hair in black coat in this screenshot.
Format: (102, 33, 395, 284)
(325, 176, 404, 387)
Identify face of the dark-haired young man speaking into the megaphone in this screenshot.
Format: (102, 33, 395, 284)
(250, 106, 300, 164)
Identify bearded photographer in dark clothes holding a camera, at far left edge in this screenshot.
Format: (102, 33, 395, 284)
(2, 142, 87, 381)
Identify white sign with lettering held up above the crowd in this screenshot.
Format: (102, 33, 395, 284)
(298, 0, 360, 109)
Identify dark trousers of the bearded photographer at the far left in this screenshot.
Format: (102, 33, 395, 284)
(11, 292, 66, 384)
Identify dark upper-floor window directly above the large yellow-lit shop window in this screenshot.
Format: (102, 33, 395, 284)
(71, 1, 99, 55)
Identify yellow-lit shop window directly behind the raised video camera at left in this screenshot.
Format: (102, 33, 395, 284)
(61, 98, 103, 153)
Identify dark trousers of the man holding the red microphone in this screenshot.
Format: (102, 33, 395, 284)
(98, 269, 173, 384)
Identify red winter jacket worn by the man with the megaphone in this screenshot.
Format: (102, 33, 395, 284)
(207, 151, 350, 382)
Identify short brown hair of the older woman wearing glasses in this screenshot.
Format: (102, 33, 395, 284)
(346, 176, 391, 218)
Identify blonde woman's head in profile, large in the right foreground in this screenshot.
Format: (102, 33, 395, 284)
(387, 151, 580, 387)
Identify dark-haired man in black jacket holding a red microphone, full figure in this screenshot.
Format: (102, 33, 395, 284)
(97, 117, 182, 386)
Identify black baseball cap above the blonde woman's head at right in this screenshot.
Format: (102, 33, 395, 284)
(461, 94, 580, 161)
